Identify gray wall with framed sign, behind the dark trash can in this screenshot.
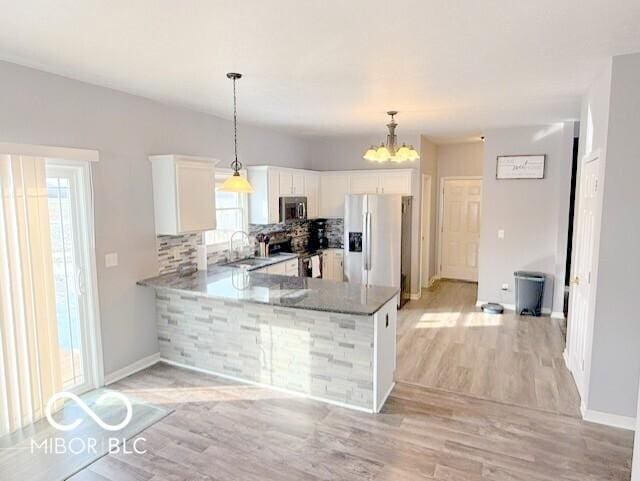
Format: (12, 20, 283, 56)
(478, 122, 574, 311)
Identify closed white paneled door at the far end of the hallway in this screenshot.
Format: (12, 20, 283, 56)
(440, 179, 482, 282)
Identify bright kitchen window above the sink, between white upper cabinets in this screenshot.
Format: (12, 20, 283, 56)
(205, 169, 249, 251)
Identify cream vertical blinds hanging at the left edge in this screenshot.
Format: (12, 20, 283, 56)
(0, 155, 61, 435)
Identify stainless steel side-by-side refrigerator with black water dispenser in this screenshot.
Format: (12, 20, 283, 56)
(344, 194, 411, 304)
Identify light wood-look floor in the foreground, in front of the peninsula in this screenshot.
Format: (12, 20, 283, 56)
(71, 364, 632, 481)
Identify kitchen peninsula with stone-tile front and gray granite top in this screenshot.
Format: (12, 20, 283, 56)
(138, 266, 398, 412)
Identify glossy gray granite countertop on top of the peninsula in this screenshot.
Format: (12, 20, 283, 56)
(138, 266, 398, 316)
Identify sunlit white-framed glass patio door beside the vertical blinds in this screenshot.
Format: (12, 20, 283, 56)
(46, 159, 102, 394)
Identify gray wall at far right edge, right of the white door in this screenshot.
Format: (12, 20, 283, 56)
(582, 54, 640, 417)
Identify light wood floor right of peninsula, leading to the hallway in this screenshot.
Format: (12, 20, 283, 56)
(396, 281, 580, 416)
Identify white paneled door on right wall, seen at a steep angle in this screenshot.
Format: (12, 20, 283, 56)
(567, 155, 600, 400)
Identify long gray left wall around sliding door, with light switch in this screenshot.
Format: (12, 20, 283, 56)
(0, 62, 310, 374)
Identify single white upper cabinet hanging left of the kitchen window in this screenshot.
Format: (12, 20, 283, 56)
(149, 155, 218, 235)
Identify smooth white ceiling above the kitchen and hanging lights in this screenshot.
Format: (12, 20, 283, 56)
(0, 0, 640, 139)
